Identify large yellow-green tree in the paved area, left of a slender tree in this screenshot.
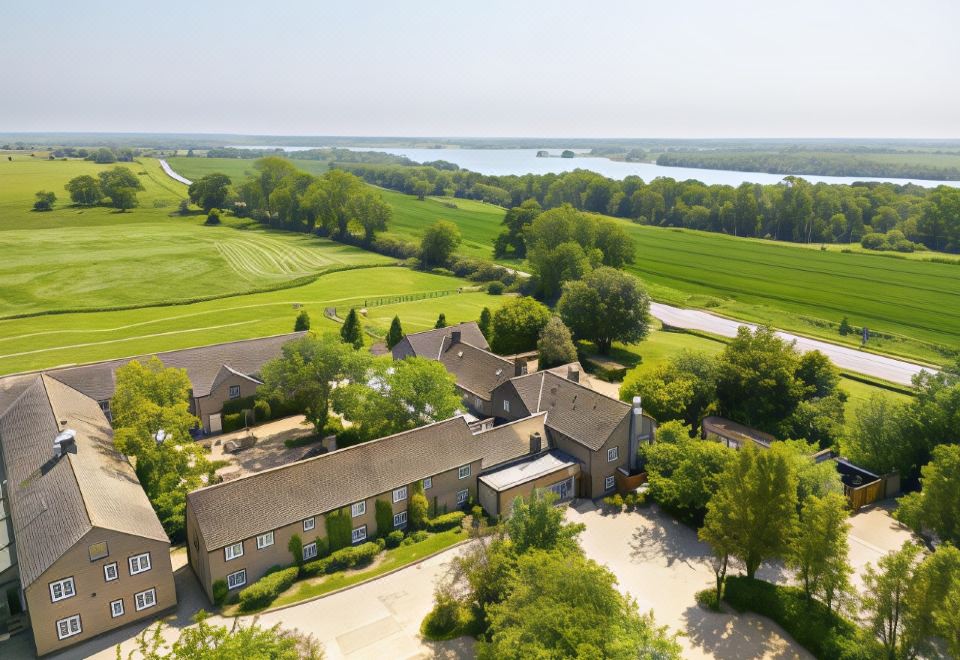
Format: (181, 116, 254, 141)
(699, 445, 797, 578)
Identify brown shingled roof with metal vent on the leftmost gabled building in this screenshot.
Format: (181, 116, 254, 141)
(0, 375, 168, 587)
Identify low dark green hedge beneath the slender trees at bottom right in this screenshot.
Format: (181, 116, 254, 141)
(723, 576, 883, 660)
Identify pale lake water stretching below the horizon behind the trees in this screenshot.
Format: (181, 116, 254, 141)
(236, 146, 960, 188)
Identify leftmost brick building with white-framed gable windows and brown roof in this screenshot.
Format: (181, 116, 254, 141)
(0, 374, 177, 655)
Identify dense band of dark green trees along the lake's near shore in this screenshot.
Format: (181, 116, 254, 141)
(336, 163, 960, 252)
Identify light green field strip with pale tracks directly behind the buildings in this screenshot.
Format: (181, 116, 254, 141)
(0, 266, 506, 374)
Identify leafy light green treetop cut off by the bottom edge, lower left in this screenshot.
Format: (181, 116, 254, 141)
(117, 610, 323, 660)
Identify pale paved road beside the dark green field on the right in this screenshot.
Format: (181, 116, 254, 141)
(650, 302, 930, 385)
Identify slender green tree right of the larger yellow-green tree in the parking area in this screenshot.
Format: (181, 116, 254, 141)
(787, 493, 853, 610)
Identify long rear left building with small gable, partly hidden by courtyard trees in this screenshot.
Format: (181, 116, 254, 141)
(4, 332, 306, 433)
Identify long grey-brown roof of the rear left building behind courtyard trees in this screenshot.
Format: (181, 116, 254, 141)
(15, 332, 306, 401)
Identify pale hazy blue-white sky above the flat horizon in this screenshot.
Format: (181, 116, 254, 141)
(0, 0, 960, 138)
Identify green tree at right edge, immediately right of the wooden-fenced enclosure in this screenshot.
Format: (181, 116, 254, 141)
(895, 445, 960, 545)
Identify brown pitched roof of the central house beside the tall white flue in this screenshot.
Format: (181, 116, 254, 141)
(502, 371, 630, 451)
